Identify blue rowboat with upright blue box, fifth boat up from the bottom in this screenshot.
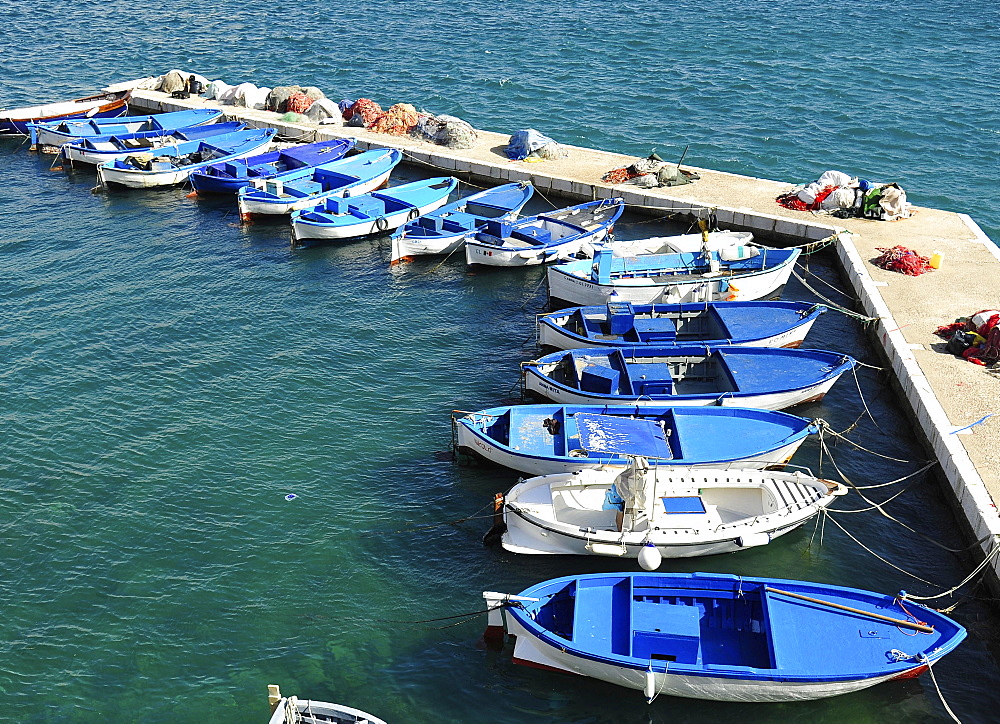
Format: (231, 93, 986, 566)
(537, 296, 826, 349)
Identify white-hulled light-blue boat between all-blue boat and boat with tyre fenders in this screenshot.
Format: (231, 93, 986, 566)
(236, 149, 403, 219)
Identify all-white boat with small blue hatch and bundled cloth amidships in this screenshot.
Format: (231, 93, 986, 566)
(494, 464, 847, 570)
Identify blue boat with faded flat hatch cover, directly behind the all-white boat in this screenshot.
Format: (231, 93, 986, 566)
(452, 405, 818, 475)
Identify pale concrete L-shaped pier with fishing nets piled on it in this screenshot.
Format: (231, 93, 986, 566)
(131, 91, 1000, 589)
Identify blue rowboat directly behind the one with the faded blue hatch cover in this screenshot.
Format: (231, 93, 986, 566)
(521, 345, 855, 410)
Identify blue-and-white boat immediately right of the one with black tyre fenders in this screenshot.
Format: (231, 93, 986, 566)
(389, 181, 535, 264)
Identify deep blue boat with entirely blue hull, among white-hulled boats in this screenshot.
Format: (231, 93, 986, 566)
(190, 138, 354, 194)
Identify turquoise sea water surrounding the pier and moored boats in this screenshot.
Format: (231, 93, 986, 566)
(0, 0, 1000, 722)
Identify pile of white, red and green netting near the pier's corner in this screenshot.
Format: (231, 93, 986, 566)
(776, 171, 913, 221)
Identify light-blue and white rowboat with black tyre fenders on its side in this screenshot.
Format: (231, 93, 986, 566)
(292, 176, 458, 246)
